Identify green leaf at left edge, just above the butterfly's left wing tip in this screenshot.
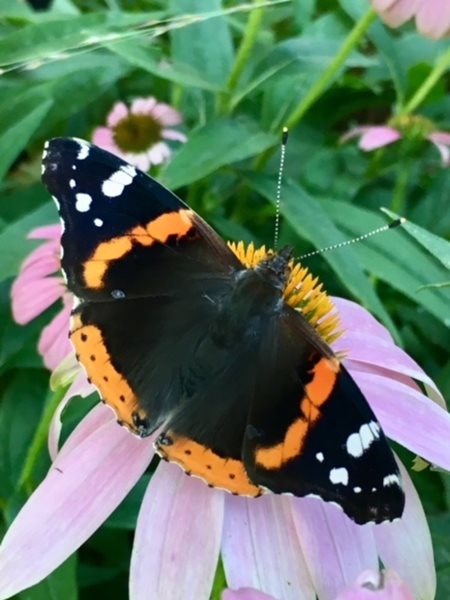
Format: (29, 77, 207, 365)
(0, 86, 53, 179)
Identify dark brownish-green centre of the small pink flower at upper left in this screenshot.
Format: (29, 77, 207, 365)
(113, 113, 162, 153)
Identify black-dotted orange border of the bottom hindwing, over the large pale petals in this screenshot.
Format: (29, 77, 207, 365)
(156, 432, 262, 497)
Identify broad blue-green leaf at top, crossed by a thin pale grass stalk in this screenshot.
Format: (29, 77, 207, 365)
(169, 0, 233, 86)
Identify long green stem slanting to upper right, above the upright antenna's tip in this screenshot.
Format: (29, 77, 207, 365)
(255, 8, 377, 168)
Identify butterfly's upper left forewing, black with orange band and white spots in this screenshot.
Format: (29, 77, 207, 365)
(42, 138, 240, 301)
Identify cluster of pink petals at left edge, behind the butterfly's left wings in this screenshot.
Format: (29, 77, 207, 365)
(11, 225, 72, 370)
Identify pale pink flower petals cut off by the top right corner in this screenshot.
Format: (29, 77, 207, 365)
(371, 0, 450, 39)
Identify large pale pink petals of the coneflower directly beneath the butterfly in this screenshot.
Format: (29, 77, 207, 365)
(0, 298, 450, 600)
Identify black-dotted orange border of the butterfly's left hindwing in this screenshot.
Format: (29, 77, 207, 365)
(70, 315, 145, 434)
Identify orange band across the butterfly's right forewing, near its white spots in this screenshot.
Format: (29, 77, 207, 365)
(255, 358, 339, 469)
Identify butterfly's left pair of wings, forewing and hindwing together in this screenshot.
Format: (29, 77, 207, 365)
(42, 138, 242, 435)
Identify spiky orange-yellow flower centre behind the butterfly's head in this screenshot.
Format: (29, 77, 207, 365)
(228, 242, 343, 344)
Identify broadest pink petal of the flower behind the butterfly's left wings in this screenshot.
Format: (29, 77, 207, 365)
(11, 277, 64, 325)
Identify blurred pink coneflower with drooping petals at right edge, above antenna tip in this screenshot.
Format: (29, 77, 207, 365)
(341, 115, 450, 167)
